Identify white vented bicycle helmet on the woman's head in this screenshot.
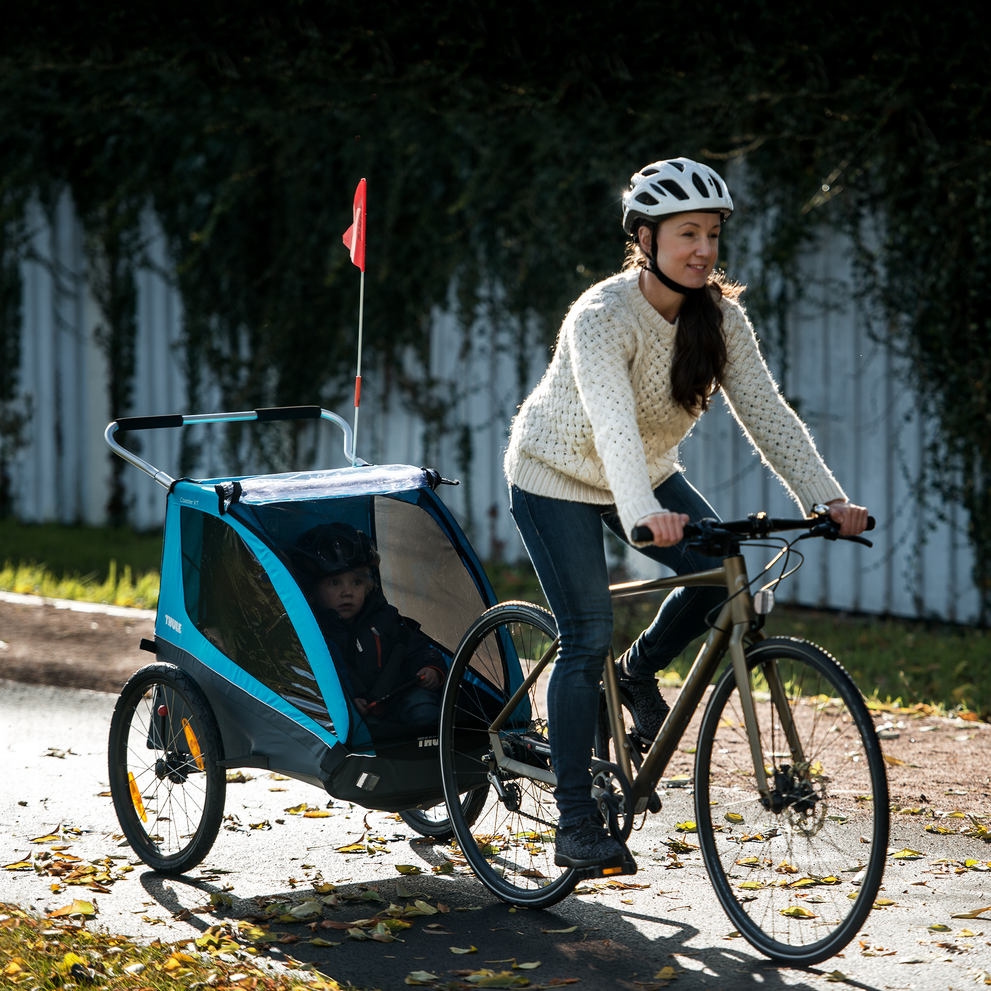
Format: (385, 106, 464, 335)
(623, 158, 733, 234)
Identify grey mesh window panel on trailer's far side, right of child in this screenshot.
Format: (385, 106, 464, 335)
(375, 496, 485, 655)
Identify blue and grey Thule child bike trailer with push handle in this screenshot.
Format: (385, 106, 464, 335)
(106, 406, 495, 873)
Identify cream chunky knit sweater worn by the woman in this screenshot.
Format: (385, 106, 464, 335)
(505, 269, 844, 534)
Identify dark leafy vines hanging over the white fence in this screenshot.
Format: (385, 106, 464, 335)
(0, 0, 991, 619)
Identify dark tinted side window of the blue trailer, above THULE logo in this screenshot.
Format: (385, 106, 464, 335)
(181, 507, 334, 732)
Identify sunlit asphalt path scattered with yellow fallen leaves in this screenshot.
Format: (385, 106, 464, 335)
(0, 681, 991, 991)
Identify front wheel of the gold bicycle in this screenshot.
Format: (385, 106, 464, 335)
(695, 637, 889, 966)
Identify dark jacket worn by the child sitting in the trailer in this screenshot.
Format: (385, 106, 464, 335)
(314, 589, 445, 701)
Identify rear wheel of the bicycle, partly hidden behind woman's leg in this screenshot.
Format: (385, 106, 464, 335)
(440, 602, 578, 908)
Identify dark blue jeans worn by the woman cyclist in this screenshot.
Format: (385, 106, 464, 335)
(510, 475, 726, 825)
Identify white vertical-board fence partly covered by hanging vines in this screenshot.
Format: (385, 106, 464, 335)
(0, 197, 978, 622)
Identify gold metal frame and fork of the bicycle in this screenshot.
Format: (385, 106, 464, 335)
(489, 554, 805, 814)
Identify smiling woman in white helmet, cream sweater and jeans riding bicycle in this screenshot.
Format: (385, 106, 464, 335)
(505, 158, 867, 867)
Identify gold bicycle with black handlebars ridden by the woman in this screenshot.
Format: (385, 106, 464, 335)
(440, 507, 889, 965)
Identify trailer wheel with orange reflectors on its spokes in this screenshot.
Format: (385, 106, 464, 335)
(108, 663, 227, 874)
